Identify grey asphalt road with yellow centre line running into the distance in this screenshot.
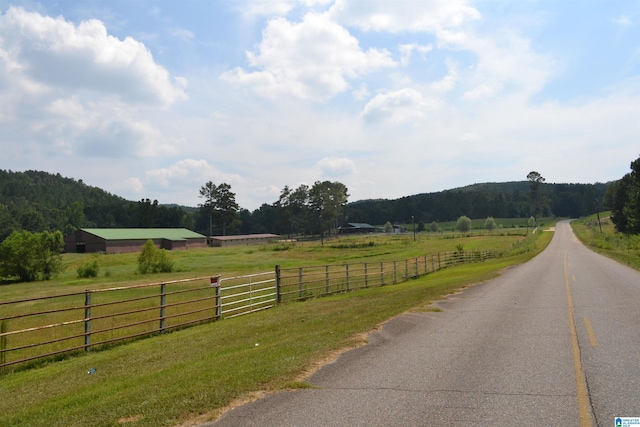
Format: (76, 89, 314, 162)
(206, 222, 640, 427)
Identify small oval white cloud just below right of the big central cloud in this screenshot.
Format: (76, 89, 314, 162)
(360, 88, 435, 124)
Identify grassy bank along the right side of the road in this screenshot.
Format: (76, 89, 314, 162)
(571, 212, 640, 270)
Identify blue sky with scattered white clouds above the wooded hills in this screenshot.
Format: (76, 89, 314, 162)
(0, 0, 640, 211)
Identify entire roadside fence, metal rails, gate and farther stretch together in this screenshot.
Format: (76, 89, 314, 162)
(0, 251, 498, 373)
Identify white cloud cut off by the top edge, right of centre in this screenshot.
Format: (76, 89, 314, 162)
(330, 0, 480, 33)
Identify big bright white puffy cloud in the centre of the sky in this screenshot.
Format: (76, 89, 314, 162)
(222, 13, 396, 99)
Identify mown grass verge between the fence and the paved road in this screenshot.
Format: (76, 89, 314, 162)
(0, 233, 552, 426)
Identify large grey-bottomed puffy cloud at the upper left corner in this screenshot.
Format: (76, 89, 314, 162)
(0, 7, 186, 105)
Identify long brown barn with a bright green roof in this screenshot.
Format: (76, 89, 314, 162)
(64, 228, 207, 254)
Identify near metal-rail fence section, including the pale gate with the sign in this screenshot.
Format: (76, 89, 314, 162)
(0, 272, 276, 369)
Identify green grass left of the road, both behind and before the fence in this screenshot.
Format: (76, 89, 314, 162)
(0, 226, 552, 426)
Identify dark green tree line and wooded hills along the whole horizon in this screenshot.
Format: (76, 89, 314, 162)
(0, 166, 639, 241)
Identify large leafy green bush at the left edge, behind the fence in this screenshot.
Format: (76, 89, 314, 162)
(0, 231, 64, 282)
